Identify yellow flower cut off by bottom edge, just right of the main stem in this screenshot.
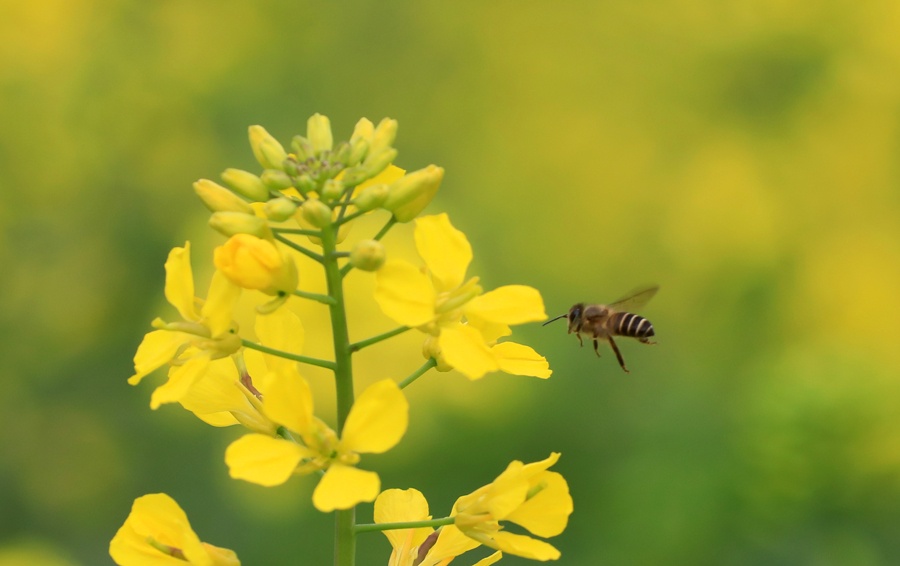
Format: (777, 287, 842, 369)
(374, 489, 501, 566)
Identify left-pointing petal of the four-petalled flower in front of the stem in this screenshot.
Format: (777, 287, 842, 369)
(225, 434, 311, 487)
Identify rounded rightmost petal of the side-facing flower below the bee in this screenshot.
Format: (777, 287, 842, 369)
(506, 472, 572, 538)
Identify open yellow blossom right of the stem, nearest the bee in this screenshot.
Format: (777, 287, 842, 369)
(375, 214, 551, 379)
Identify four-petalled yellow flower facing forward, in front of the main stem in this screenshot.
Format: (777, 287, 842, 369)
(225, 374, 409, 512)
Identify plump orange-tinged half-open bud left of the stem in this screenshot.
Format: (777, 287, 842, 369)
(213, 234, 298, 295)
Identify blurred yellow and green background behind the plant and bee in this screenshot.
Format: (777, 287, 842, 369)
(0, 0, 900, 566)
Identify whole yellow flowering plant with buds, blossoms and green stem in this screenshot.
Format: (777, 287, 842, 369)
(116, 114, 572, 565)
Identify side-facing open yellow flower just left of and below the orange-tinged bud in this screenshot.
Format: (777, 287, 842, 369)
(128, 242, 241, 409)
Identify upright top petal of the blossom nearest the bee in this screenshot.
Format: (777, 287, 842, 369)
(415, 214, 472, 290)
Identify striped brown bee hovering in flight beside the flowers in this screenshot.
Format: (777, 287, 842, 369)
(542, 285, 659, 373)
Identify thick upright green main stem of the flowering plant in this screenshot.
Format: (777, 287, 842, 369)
(322, 226, 356, 566)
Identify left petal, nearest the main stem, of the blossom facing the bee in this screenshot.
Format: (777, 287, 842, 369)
(375, 260, 437, 327)
